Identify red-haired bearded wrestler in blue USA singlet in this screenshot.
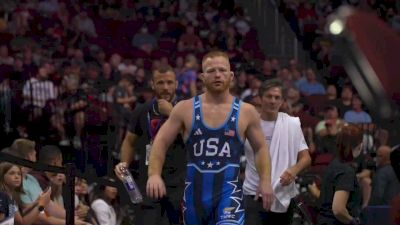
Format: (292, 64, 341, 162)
(146, 51, 272, 225)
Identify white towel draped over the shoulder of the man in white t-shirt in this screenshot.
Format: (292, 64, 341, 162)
(269, 113, 302, 213)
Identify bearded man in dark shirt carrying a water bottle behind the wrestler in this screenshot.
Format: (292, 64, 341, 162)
(115, 66, 185, 225)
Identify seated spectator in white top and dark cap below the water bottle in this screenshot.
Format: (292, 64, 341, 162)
(91, 180, 118, 225)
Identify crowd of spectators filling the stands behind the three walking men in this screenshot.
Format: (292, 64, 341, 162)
(0, 0, 400, 224)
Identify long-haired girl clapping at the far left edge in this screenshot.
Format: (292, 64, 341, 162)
(0, 162, 51, 225)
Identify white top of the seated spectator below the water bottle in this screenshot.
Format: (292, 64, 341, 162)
(91, 199, 117, 225)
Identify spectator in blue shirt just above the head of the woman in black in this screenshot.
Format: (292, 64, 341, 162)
(344, 95, 372, 124)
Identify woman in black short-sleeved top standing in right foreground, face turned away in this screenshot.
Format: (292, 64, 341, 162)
(312, 125, 362, 225)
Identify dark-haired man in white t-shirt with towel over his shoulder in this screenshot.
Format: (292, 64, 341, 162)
(243, 79, 311, 225)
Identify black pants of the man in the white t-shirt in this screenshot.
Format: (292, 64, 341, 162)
(244, 195, 293, 225)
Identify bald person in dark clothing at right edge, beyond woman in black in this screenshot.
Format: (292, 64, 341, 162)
(369, 146, 400, 205)
